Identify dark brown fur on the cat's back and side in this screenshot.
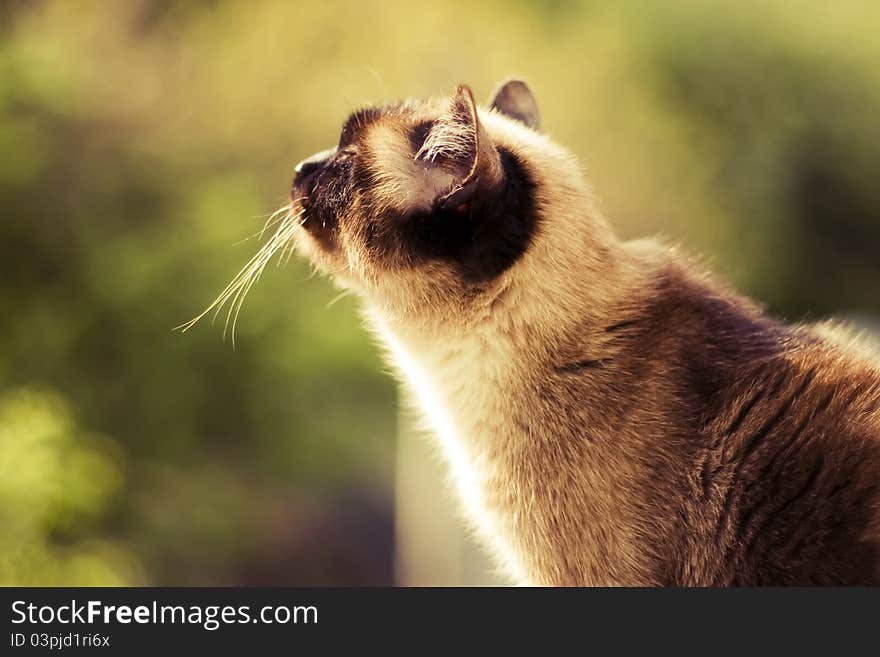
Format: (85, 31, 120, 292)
(552, 254, 880, 585)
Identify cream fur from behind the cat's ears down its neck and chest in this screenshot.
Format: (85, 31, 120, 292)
(366, 111, 660, 584)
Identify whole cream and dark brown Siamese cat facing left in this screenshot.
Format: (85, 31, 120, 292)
(189, 80, 880, 586)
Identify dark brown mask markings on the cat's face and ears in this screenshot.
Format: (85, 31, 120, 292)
(291, 81, 538, 283)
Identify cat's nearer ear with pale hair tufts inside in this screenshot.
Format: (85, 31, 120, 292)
(416, 85, 504, 209)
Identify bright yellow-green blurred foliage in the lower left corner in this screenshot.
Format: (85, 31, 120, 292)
(0, 389, 139, 586)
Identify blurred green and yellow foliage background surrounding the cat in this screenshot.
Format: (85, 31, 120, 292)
(0, 0, 880, 584)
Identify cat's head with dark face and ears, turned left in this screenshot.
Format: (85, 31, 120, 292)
(291, 80, 600, 322)
